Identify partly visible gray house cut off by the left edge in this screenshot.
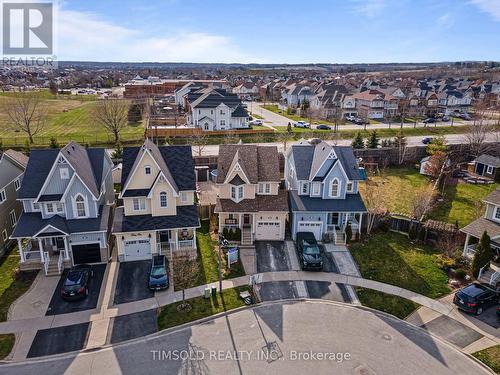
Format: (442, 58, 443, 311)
(0, 150, 28, 255)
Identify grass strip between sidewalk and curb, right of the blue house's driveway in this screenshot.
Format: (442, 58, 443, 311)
(356, 288, 420, 319)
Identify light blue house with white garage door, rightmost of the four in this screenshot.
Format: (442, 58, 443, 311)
(285, 139, 366, 243)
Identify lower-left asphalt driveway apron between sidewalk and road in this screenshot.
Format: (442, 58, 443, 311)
(27, 323, 90, 358)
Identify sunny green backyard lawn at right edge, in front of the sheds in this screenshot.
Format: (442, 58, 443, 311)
(429, 183, 499, 228)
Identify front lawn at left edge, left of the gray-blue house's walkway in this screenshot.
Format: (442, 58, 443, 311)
(0, 247, 38, 322)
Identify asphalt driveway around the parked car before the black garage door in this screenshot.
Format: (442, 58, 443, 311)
(45, 264, 107, 315)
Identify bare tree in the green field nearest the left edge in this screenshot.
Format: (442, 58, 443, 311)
(2, 91, 47, 143)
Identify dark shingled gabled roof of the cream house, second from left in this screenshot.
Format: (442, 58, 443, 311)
(121, 140, 196, 196)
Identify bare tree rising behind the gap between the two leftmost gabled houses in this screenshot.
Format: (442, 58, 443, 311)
(91, 99, 130, 144)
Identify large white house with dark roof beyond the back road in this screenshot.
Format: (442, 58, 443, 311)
(186, 88, 250, 131)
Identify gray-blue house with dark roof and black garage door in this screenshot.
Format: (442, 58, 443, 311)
(11, 142, 114, 275)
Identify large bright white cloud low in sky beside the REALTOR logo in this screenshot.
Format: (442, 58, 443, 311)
(57, 9, 261, 62)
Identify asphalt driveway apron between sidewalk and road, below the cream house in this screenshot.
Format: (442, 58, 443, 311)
(106, 309, 158, 344)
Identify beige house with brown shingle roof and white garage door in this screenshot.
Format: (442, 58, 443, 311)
(215, 144, 288, 245)
